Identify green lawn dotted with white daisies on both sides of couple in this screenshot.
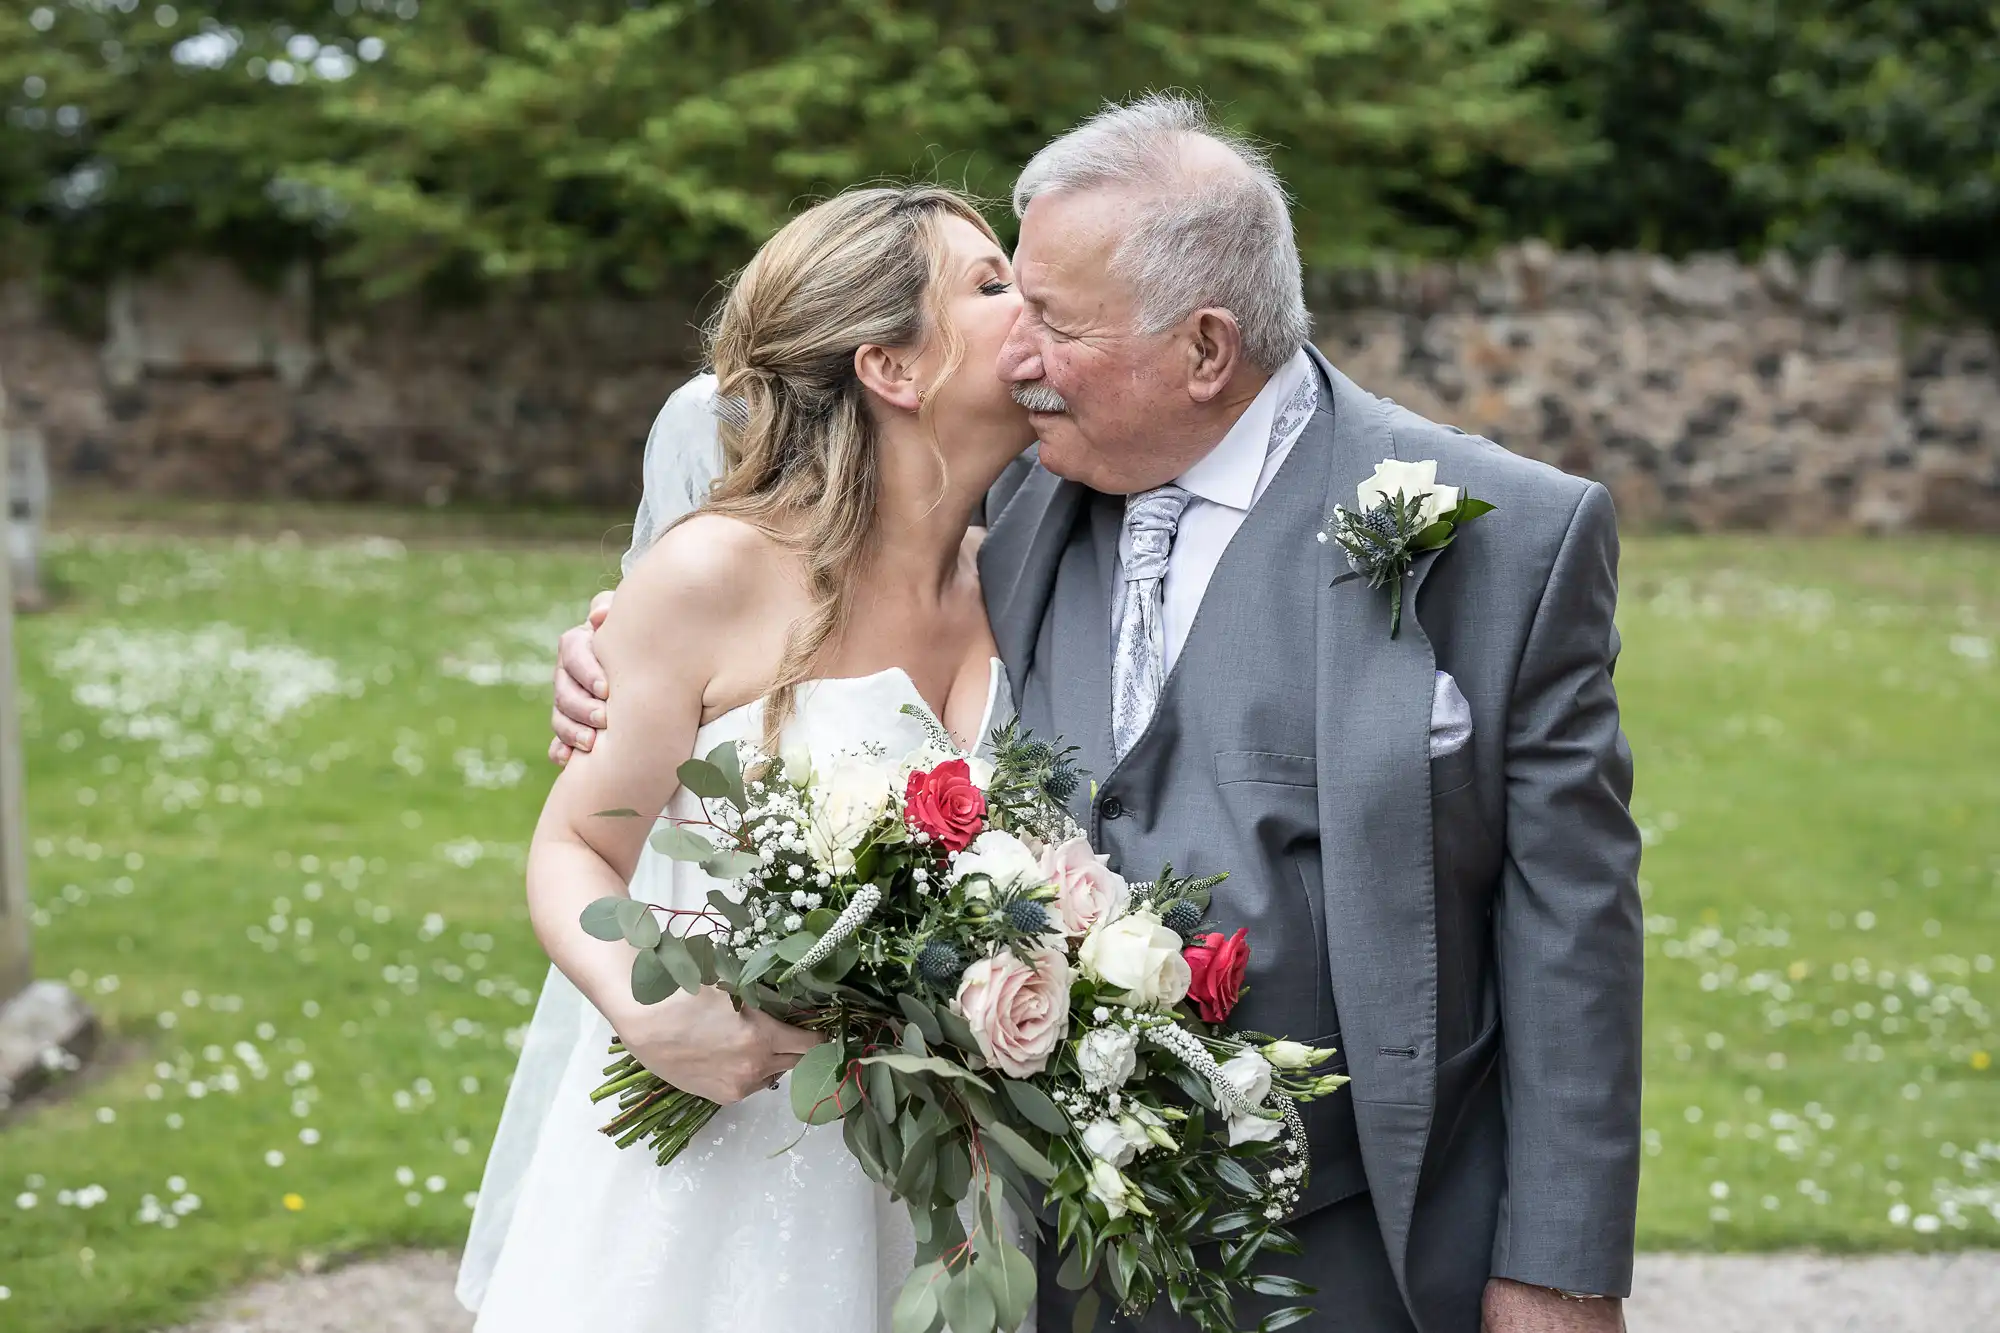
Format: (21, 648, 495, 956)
(0, 518, 2000, 1333)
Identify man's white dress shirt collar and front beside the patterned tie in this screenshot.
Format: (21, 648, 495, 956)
(1112, 348, 1312, 673)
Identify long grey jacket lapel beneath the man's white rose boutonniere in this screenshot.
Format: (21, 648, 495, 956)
(1314, 340, 1438, 1279)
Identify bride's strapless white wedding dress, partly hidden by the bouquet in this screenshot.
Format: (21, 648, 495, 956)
(458, 660, 1012, 1333)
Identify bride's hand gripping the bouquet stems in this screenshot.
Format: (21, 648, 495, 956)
(612, 987, 820, 1107)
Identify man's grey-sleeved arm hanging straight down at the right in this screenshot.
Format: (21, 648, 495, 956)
(1492, 482, 1644, 1296)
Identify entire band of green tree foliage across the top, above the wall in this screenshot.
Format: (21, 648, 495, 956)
(0, 0, 2000, 310)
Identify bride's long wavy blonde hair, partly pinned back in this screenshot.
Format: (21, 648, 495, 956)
(702, 184, 998, 751)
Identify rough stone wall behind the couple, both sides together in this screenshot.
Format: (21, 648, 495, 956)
(0, 244, 2000, 532)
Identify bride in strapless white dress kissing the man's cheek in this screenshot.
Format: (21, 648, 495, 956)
(458, 186, 1034, 1333)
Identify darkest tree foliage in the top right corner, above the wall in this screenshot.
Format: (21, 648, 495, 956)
(1484, 0, 2000, 314)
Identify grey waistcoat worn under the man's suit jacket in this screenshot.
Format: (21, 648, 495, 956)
(1016, 382, 1366, 1209)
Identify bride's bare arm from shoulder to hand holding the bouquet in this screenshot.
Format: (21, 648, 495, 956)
(528, 520, 812, 1103)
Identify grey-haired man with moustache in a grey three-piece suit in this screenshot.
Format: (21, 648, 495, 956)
(556, 96, 1642, 1333)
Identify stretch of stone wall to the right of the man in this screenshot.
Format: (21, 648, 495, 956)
(1314, 244, 2000, 532)
